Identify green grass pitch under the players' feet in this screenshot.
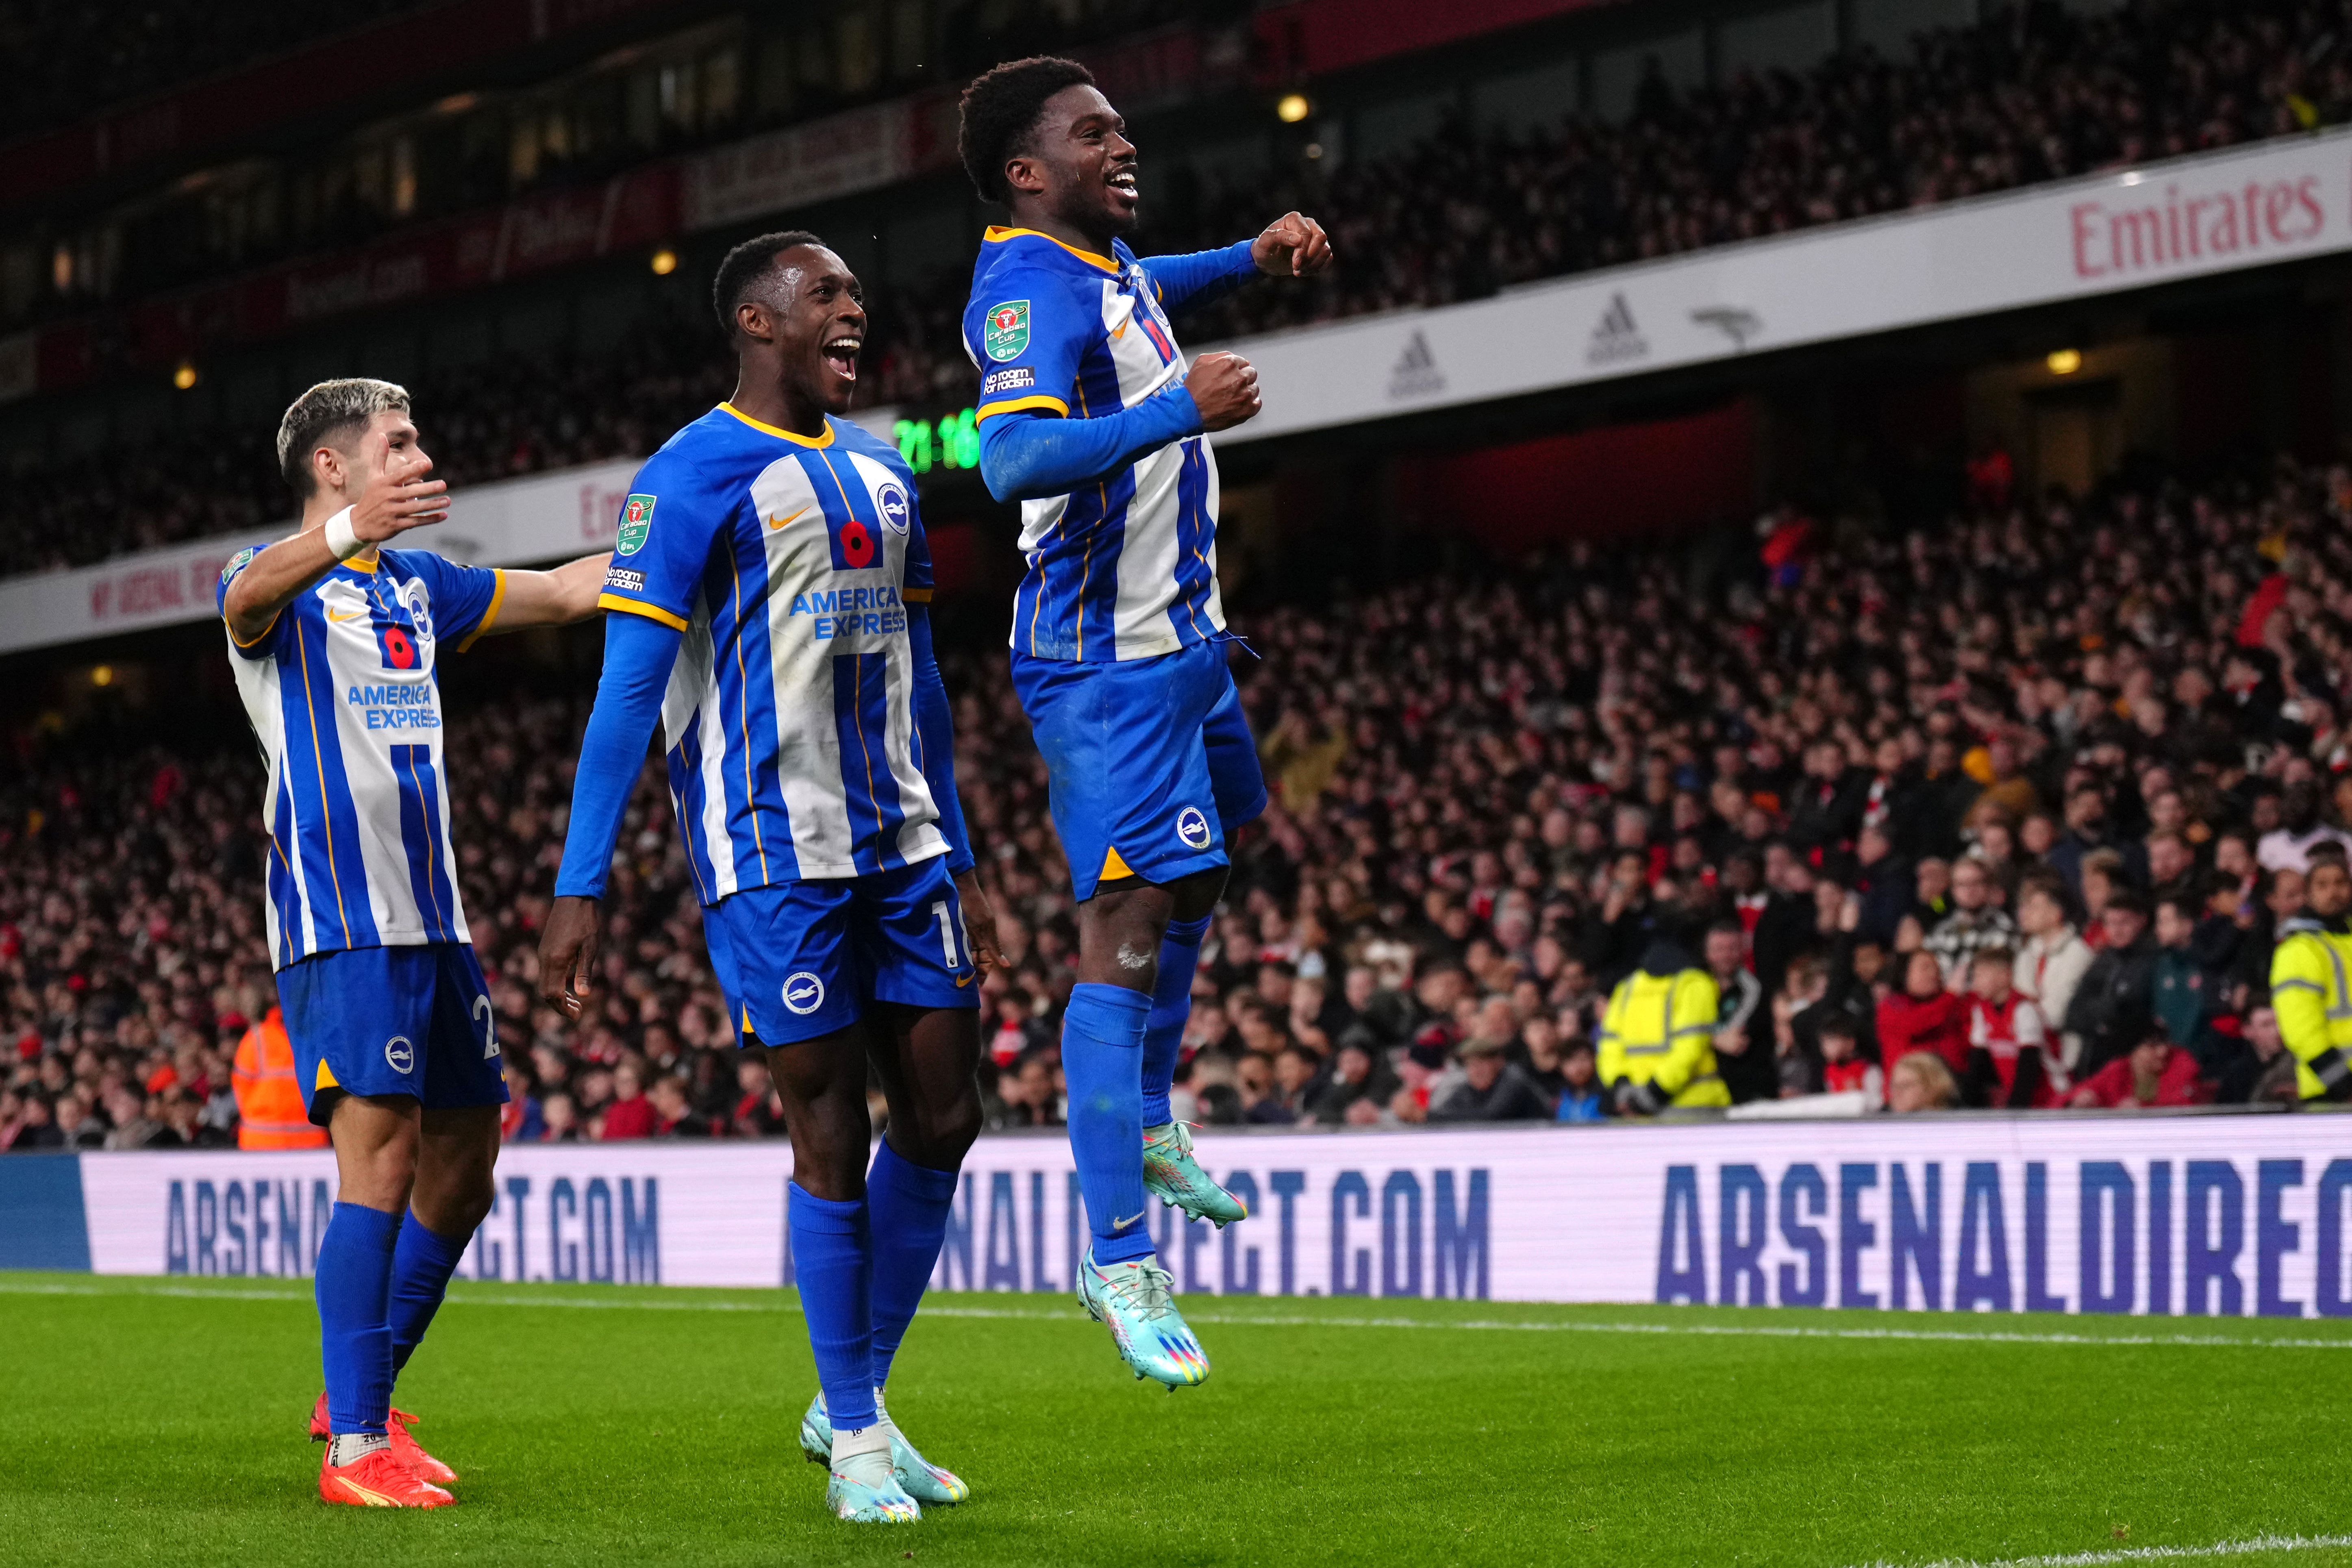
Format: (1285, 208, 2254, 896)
(0, 1274, 2352, 1568)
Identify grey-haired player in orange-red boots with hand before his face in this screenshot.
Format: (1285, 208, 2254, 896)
(219, 378, 604, 1507)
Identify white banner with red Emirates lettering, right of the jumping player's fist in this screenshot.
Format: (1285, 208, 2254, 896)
(1216, 132, 2352, 447)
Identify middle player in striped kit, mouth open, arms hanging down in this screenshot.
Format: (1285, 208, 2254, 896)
(539, 231, 997, 1523)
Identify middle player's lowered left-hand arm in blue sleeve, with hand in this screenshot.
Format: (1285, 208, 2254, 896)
(539, 613, 685, 1018)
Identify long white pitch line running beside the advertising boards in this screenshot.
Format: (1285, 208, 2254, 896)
(0, 1279, 2352, 1354)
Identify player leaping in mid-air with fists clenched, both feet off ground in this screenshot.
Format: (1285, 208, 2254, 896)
(960, 59, 1331, 1390)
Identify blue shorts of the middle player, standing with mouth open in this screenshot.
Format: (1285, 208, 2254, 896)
(703, 856, 981, 1046)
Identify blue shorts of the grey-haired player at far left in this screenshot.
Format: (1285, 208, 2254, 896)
(278, 943, 506, 1126)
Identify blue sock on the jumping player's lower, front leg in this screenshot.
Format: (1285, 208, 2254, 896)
(1061, 985, 1152, 1262)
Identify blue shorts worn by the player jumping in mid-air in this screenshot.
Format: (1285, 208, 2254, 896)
(1014, 642, 1265, 903)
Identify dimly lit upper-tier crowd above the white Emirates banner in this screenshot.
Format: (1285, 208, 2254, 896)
(18, 0, 2352, 571)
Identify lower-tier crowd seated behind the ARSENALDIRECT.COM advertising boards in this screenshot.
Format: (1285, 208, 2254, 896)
(0, 442, 2324, 1147)
